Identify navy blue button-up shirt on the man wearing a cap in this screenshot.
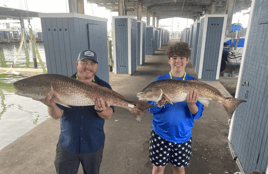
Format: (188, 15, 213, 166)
(57, 74, 114, 154)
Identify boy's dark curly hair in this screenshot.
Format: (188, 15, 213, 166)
(167, 42, 191, 58)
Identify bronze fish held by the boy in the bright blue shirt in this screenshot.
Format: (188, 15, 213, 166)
(137, 79, 245, 117)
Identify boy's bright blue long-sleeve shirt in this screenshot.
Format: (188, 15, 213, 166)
(148, 73, 204, 143)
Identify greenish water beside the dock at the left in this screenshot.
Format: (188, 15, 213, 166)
(0, 43, 50, 150)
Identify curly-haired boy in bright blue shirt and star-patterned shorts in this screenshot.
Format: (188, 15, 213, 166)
(149, 42, 204, 174)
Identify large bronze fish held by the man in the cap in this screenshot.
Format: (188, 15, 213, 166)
(13, 74, 154, 121)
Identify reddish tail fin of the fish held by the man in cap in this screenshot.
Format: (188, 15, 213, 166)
(128, 102, 154, 122)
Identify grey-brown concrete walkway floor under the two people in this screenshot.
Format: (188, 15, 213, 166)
(0, 41, 239, 174)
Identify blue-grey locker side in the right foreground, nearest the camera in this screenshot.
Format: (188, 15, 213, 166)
(231, 0, 268, 173)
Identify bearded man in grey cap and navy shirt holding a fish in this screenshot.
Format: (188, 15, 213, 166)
(34, 50, 114, 174)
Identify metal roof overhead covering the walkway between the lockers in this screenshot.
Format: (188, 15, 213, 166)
(87, 0, 251, 19)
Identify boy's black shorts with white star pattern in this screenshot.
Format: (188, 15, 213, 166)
(149, 130, 192, 167)
